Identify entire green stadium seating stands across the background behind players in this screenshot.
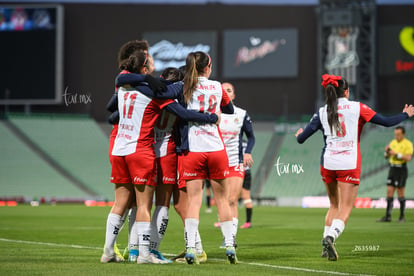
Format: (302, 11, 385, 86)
(0, 114, 414, 200)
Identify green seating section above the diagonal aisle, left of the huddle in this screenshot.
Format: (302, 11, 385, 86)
(4, 115, 113, 202)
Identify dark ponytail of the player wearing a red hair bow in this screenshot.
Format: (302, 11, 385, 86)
(325, 79, 349, 133)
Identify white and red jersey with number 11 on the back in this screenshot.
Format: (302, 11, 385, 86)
(112, 87, 172, 156)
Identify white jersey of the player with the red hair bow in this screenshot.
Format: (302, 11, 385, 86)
(319, 98, 375, 170)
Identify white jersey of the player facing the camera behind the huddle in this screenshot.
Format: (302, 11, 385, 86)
(219, 105, 246, 167)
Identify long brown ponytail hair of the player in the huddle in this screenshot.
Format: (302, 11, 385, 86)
(183, 51, 211, 103)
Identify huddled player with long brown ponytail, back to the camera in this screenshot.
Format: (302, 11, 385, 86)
(179, 51, 237, 264)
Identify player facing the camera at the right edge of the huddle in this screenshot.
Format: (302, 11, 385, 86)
(219, 82, 255, 244)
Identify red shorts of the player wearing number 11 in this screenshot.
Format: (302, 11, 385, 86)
(111, 150, 156, 186)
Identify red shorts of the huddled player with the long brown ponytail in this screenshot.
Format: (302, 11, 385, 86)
(180, 149, 229, 180)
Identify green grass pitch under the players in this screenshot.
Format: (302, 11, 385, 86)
(0, 205, 414, 276)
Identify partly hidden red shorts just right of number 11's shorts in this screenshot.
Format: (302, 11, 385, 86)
(157, 151, 177, 184)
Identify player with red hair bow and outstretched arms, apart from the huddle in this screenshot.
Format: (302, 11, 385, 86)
(296, 74, 414, 261)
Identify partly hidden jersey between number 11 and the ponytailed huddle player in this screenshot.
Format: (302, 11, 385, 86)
(154, 110, 177, 158)
